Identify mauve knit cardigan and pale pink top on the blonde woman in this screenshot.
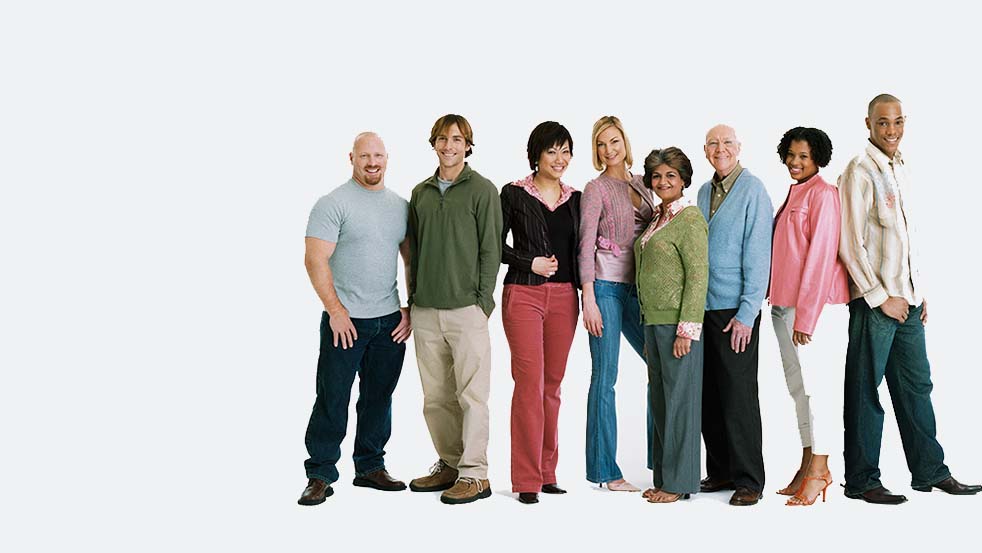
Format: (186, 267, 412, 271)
(577, 175, 655, 284)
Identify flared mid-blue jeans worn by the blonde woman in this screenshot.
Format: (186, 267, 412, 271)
(586, 280, 653, 483)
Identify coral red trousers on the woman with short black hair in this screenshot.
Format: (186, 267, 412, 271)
(501, 282, 579, 492)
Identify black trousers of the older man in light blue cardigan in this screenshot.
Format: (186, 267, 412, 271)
(702, 309, 764, 492)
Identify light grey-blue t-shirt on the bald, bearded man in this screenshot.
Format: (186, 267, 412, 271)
(307, 179, 409, 319)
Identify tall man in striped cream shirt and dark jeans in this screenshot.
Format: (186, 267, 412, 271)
(839, 94, 982, 505)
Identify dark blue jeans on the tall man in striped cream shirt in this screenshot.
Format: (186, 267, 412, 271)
(844, 298, 951, 493)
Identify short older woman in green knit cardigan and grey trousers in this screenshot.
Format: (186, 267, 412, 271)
(634, 147, 709, 503)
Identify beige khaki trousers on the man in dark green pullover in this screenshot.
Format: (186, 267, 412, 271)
(412, 305, 491, 479)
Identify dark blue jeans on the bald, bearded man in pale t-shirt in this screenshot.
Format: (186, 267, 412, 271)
(303, 311, 406, 484)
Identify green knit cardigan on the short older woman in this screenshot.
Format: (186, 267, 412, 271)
(634, 205, 709, 325)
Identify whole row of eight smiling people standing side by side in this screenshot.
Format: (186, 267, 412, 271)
(299, 94, 982, 505)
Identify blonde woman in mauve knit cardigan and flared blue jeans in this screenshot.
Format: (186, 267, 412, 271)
(578, 115, 655, 491)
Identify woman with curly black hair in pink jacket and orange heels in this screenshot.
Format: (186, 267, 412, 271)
(769, 127, 849, 505)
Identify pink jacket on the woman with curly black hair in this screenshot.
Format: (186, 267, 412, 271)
(768, 174, 849, 334)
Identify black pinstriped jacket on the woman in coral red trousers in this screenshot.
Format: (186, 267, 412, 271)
(501, 183, 580, 288)
